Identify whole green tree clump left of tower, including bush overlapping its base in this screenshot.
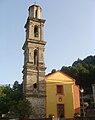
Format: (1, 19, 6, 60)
(0, 81, 32, 119)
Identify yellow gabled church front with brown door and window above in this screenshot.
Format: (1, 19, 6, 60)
(45, 71, 80, 118)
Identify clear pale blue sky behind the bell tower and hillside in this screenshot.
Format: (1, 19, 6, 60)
(0, 0, 95, 85)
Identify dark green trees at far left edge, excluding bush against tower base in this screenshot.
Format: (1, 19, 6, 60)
(0, 81, 23, 113)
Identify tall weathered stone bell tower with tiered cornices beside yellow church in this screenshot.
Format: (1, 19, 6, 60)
(23, 4, 46, 118)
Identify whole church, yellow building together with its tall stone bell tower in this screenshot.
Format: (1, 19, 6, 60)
(22, 4, 80, 118)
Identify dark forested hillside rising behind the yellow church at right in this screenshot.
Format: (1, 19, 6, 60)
(61, 55, 95, 94)
